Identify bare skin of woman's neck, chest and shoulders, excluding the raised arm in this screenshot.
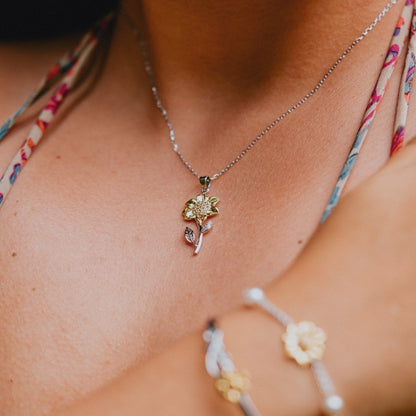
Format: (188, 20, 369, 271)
(0, 0, 416, 416)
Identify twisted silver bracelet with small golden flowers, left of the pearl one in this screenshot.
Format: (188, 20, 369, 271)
(203, 321, 261, 416)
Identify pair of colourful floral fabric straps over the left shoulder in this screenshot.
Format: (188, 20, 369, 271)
(0, 15, 112, 206)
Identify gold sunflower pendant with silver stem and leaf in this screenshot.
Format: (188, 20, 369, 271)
(182, 176, 220, 254)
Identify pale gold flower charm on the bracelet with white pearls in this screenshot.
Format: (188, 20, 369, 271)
(282, 321, 326, 366)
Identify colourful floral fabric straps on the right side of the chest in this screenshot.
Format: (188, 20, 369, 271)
(321, 0, 415, 223)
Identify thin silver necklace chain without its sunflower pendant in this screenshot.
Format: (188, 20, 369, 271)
(124, 0, 397, 181)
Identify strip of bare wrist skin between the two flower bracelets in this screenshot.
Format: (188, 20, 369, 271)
(219, 309, 322, 416)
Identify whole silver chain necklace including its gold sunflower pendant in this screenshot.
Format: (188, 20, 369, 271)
(122, 0, 397, 254)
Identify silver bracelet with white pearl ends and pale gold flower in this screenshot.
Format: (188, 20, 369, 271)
(244, 288, 344, 415)
